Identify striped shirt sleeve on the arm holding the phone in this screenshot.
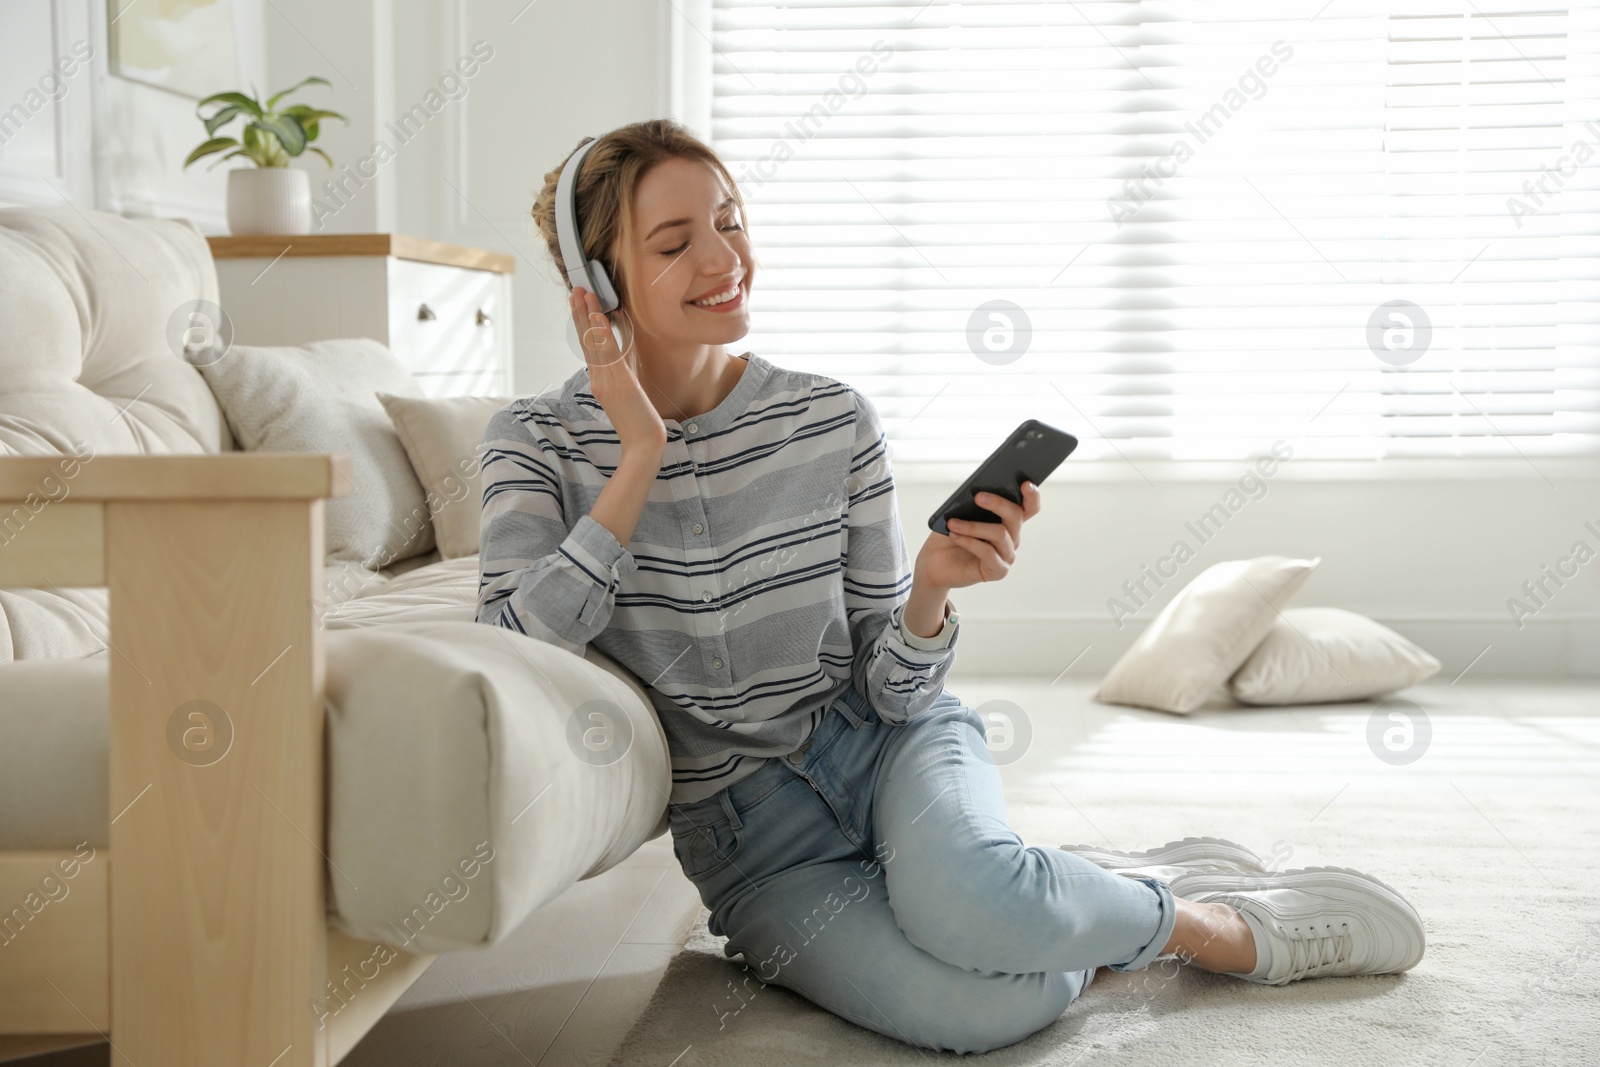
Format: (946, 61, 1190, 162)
(843, 390, 958, 726)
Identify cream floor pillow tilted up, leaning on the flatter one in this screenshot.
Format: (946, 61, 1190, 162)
(1094, 555, 1322, 715)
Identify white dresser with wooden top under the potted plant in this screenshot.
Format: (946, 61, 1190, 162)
(208, 234, 515, 397)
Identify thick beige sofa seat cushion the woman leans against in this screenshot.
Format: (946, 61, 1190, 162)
(0, 621, 670, 952)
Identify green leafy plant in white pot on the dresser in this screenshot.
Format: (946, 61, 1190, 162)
(184, 77, 350, 234)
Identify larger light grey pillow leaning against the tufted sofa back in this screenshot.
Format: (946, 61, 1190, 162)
(200, 338, 434, 569)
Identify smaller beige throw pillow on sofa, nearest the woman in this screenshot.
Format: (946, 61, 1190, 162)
(378, 394, 514, 560)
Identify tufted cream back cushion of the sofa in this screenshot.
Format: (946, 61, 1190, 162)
(0, 205, 237, 661)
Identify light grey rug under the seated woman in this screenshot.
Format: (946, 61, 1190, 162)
(611, 777, 1600, 1067)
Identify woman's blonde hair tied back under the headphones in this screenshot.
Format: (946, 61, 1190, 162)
(533, 118, 749, 307)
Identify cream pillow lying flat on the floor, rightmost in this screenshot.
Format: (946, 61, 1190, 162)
(1227, 608, 1438, 704)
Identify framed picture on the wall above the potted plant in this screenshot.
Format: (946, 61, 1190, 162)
(106, 0, 238, 99)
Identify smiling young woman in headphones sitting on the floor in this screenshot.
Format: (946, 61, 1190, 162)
(478, 120, 1422, 1053)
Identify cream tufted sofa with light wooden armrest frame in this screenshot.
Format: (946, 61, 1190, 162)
(0, 206, 670, 1067)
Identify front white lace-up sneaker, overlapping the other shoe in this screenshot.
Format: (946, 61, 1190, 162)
(1174, 867, 1426, 985)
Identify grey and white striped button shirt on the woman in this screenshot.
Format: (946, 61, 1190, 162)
(477, 354, 958, 803)
